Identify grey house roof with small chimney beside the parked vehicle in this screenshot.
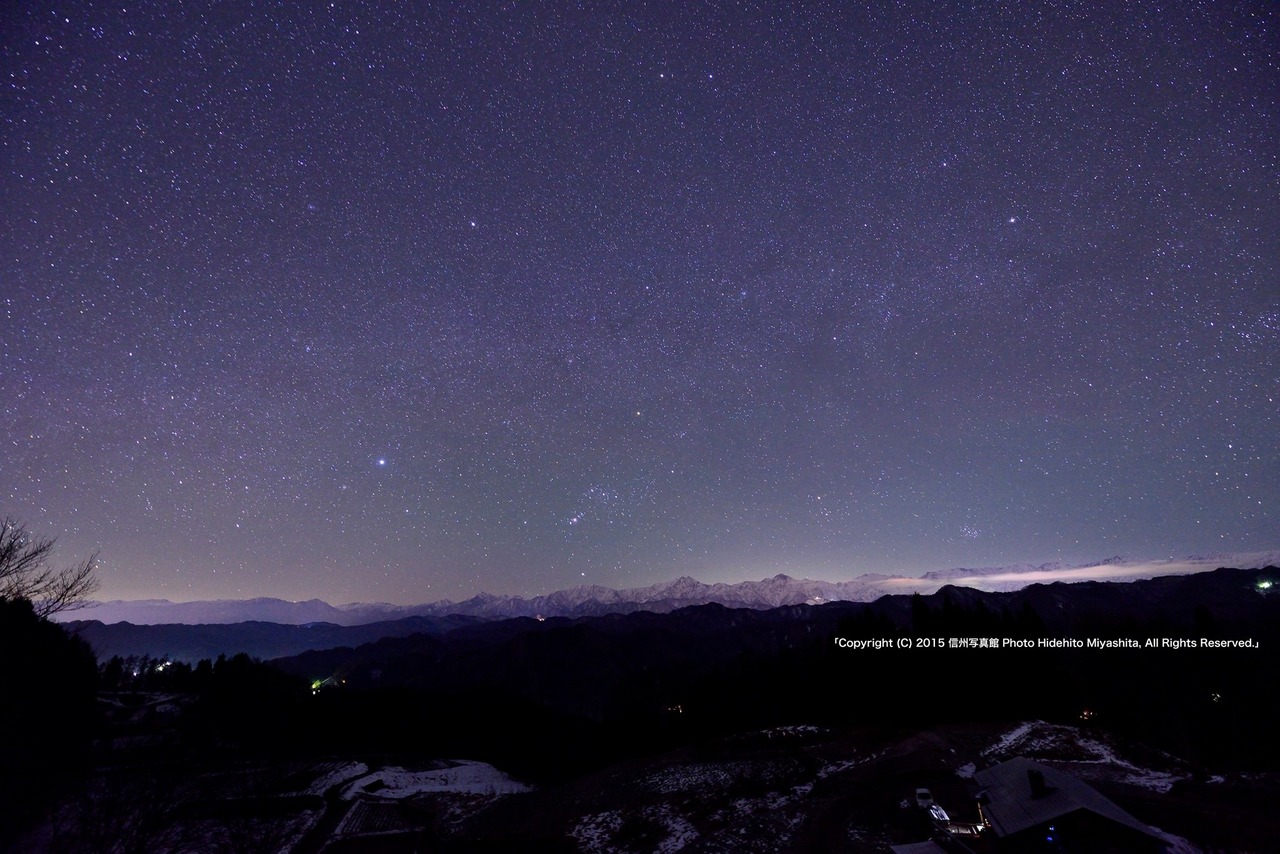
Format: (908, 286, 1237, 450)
(973, 757, 1155, 836)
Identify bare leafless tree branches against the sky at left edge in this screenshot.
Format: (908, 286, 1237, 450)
(0, 517, 97, 617)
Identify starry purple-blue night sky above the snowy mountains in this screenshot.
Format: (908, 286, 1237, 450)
(0, 0, 1280, 603)
